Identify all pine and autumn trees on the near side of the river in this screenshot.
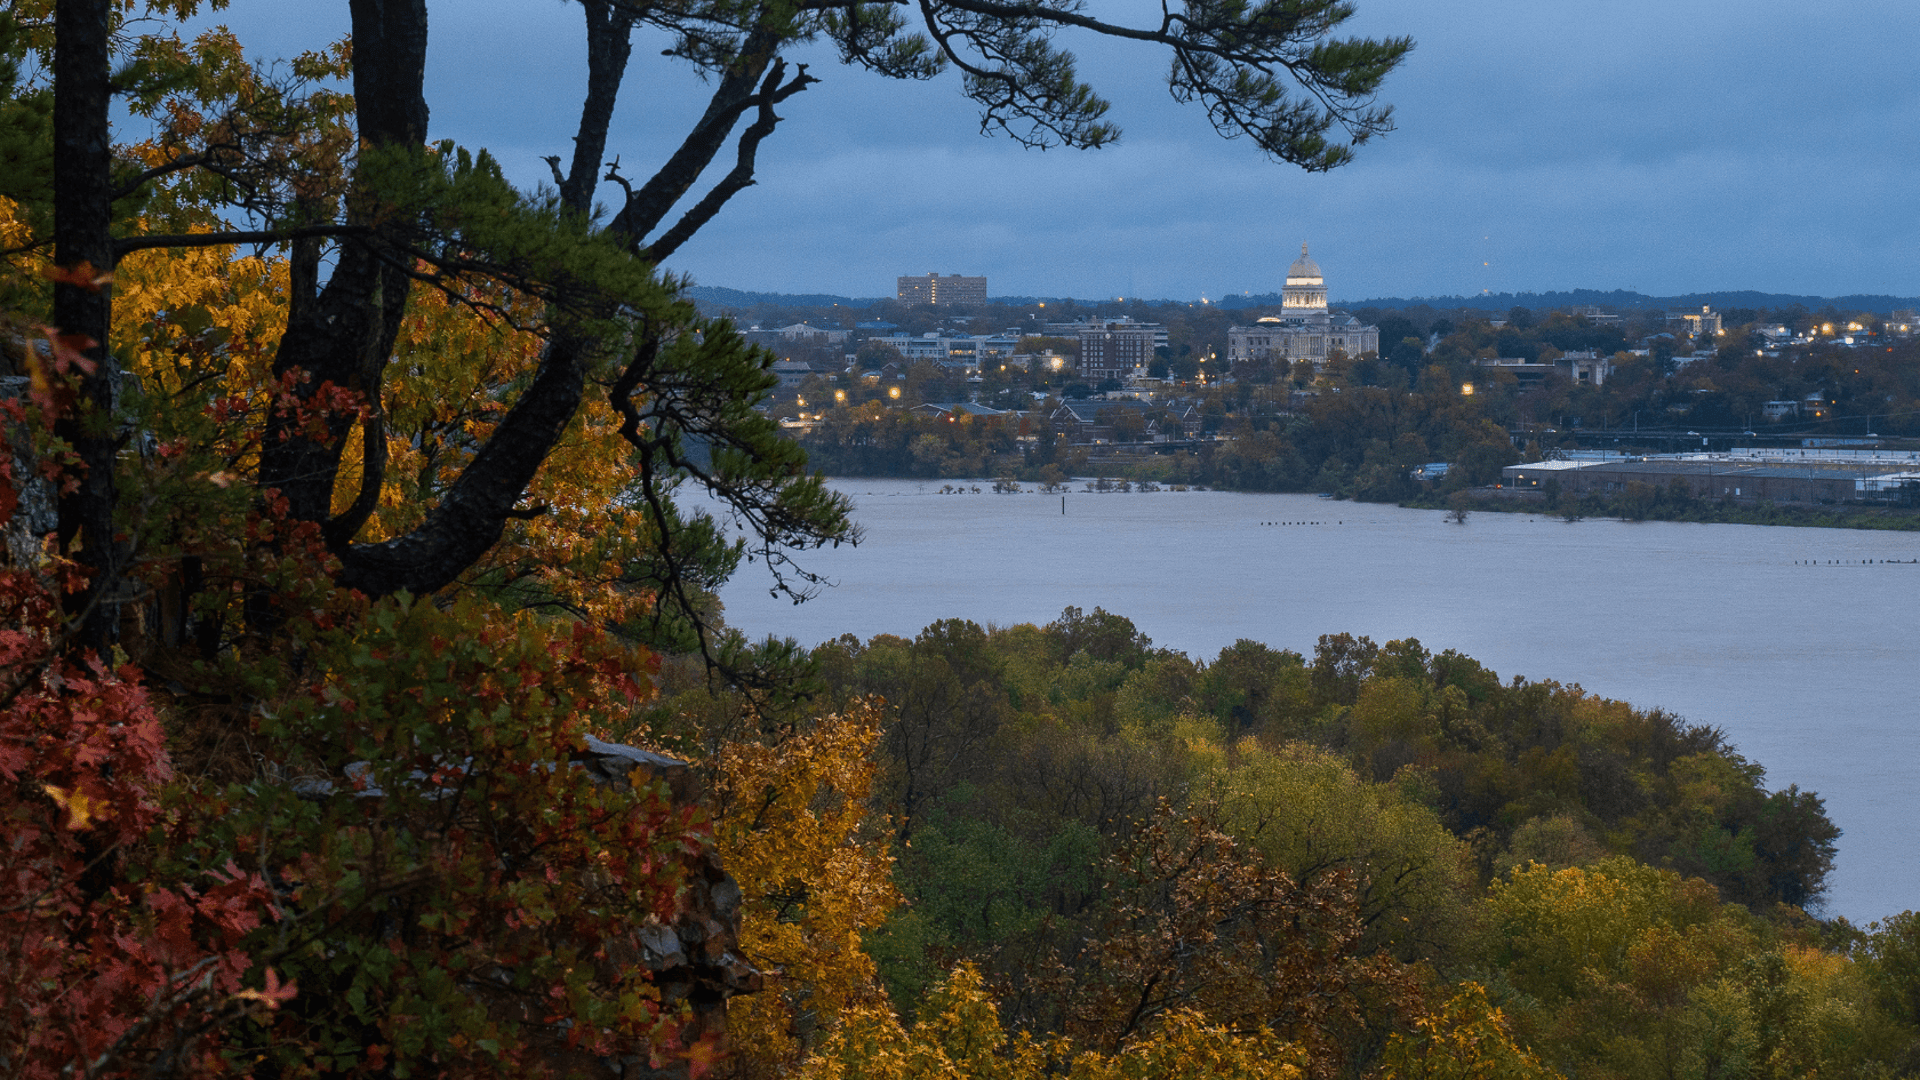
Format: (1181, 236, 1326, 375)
(11, 0, 1920, 1080)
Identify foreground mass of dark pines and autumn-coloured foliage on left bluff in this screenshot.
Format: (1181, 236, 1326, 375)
(0, 0, 1407, 1076)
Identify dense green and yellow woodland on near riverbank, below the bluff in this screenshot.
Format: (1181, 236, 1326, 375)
(655, 607, 1920, 1078)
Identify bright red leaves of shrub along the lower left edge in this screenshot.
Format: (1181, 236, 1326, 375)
(0, 484, 290, 1080)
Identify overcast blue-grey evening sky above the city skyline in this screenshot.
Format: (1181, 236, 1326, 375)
(183, 0, 1920, 300)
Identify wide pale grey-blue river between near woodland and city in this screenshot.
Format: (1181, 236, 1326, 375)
(722, 480, 1920, 922)
